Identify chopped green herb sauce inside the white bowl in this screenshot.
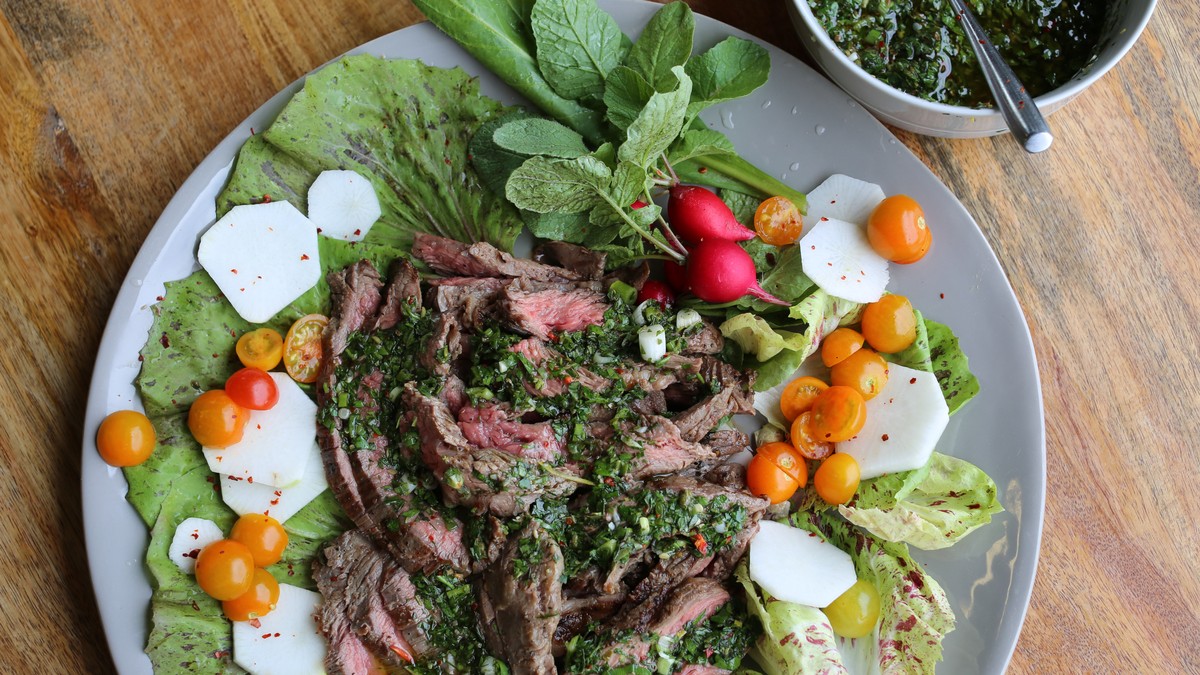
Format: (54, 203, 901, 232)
(809, 0, 1105, 108)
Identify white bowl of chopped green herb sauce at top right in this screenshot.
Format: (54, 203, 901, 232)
(790, 0, 1157, 138)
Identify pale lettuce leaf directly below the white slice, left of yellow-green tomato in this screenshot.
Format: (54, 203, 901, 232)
(736, 560, 846, 675)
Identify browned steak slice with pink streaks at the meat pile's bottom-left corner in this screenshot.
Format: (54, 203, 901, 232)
(312, 530, 428, 674)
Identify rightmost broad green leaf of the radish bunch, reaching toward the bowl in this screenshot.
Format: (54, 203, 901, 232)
(684, 37, 770, 117)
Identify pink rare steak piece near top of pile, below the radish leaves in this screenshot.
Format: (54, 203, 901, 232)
(499, 283, 608, 340)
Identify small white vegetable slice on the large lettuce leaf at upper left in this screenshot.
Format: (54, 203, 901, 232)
(308, 171, 383, 241)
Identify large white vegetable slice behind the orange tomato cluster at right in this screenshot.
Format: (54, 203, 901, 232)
(838, 364, 950, 480)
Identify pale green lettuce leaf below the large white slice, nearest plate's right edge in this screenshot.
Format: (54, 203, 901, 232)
(838, 453, 1004, 550)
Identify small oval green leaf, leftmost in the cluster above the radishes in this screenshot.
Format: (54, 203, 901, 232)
(504, 156, 612, 214)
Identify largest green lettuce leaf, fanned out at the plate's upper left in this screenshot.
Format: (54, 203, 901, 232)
(217, 54, 521, 250)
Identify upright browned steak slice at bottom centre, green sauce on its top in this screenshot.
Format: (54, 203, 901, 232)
(479, 520, 563, 675)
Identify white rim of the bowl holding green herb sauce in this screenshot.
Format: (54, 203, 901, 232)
(791, 0, 1158, 120)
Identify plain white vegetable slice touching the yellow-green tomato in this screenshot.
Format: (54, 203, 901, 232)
(750, 520, 857, 608)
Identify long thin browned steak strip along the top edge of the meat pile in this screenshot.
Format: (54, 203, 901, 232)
(413, 233, 581, 281)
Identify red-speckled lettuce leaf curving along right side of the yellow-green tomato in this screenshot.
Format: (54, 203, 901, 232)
(791, 510, 955, 675)
